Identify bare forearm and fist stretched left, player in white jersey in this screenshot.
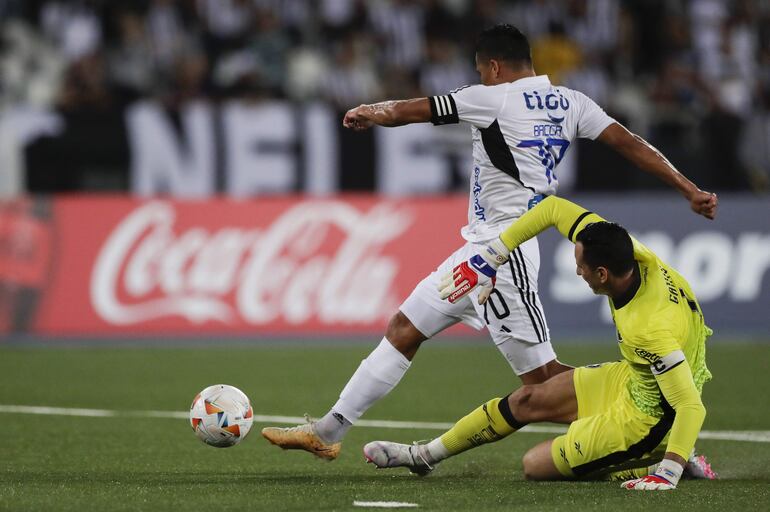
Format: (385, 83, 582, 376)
(342, 98, 431, 131)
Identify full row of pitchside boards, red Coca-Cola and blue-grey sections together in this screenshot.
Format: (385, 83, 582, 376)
(0, 196, 770, 339)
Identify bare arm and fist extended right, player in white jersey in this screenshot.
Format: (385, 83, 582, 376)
(597, 122, 718, 219)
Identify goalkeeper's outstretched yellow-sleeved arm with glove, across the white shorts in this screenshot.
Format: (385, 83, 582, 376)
(439, 196, 604, 304)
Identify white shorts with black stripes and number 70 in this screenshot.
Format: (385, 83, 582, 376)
(399, 238, 556, 375)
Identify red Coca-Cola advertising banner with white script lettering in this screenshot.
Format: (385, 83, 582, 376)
(0, 197, 467, 336)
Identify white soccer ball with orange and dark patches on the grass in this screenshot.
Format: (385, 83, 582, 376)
(190, 384, 254, 448)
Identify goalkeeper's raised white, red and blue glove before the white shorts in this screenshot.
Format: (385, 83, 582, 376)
(438, 238, 510, 304)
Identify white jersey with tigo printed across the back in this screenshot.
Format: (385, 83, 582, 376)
(429, 75, 615, 243)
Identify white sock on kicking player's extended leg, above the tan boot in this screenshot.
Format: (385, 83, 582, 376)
(315, 338, 412, 443)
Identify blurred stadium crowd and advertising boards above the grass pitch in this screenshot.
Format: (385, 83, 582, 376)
(0, 0, 770, 338)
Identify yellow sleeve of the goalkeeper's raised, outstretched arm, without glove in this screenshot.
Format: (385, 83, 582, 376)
(500, 196, 604, 250)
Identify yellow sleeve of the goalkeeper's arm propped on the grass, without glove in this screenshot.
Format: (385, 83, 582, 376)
(653, 360, 706, 460)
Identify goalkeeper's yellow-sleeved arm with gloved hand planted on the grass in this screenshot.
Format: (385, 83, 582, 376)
(623, 350, 706, 490)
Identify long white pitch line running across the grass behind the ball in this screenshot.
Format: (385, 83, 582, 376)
(0, 405, 770, 443)
